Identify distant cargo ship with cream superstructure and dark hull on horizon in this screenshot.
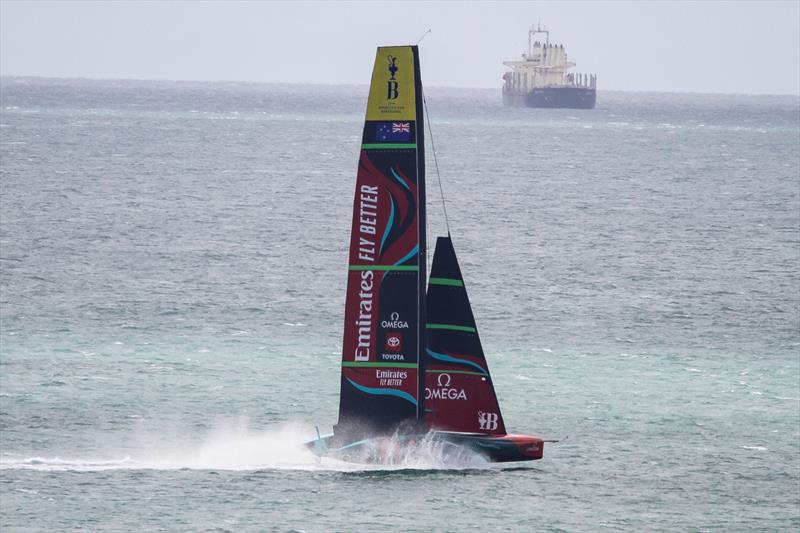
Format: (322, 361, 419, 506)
(503, 24, 597, 109)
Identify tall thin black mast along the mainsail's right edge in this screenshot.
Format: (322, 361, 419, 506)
(411, 45, 428, 426)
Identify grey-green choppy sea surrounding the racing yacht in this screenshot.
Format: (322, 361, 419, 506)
(0, 78, 800, 533)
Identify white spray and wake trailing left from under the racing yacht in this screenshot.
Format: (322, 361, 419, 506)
(0, 421, 487, 471)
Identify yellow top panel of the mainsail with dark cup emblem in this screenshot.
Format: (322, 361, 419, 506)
(367, 46, 417, 120)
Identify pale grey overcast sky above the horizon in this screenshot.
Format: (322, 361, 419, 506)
(0, 0, 800, 94)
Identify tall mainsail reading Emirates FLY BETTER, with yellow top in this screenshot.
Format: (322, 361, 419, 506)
(334, 46, 426, 437)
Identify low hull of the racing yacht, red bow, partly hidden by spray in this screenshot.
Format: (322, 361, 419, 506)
(306, 431, 544, 464)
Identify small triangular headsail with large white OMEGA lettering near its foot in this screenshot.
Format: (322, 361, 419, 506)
(424, 236, 506, 435)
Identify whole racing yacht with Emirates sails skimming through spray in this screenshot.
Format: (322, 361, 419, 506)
(307, 46, 545, 462)
